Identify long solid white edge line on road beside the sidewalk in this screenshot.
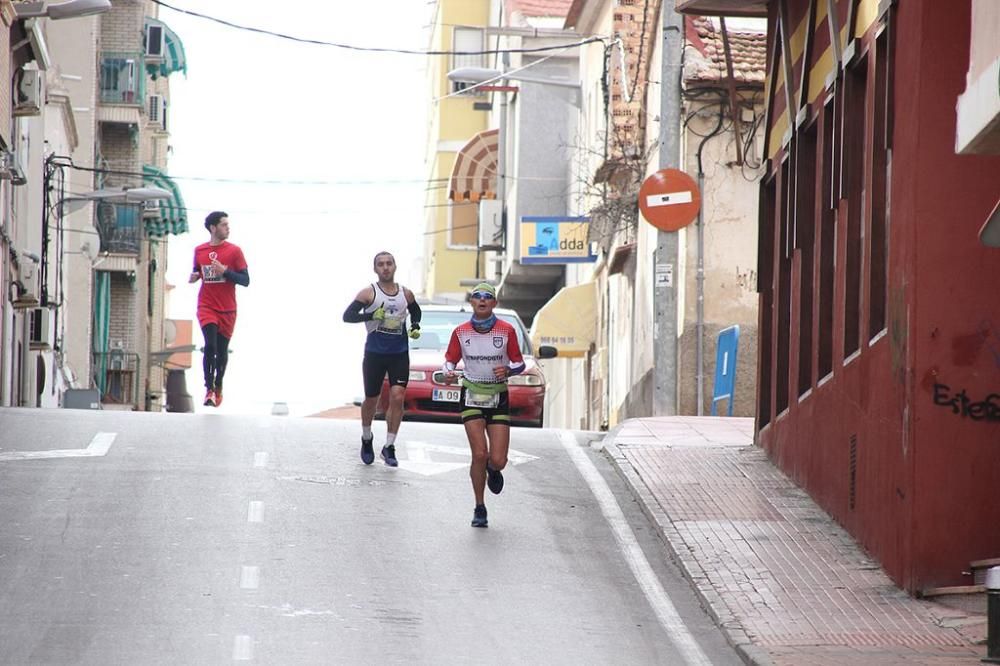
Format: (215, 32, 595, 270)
(559, 430, 712, 666)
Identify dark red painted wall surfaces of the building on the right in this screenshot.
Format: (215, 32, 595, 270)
(759, 0, 1000, 592)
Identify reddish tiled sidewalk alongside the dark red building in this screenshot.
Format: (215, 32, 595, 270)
(605, 417, 986, 666)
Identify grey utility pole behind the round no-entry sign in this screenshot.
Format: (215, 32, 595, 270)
(653, 0, 684, 416)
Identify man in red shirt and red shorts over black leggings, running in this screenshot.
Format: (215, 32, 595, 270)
(188, 211, 250, 407)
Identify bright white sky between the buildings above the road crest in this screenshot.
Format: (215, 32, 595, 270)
(160, 0, 430, 415)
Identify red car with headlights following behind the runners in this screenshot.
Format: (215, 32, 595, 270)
(375, 304, 556, 428)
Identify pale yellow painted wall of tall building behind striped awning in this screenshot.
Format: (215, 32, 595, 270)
(424, 0, 490, 298)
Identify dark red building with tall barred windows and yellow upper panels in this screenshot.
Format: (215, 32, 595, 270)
(686, 0, 1000, 592)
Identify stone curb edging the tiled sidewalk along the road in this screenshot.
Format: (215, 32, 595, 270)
(602, 423, 773, 666)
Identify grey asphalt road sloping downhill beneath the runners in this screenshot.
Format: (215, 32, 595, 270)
(0, 409, 740, 666)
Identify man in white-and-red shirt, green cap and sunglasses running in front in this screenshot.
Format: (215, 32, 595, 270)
(442, 282, 524, 527)
